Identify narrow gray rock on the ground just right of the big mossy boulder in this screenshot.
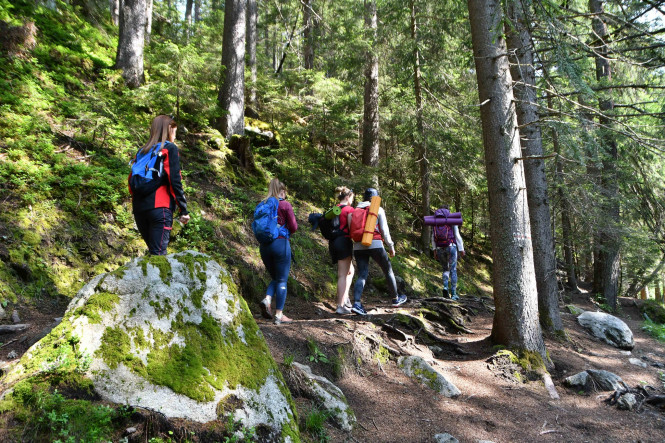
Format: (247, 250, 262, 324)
(288, 362, 356, 432)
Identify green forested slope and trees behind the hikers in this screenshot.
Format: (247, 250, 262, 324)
(0, 0, 665, 440)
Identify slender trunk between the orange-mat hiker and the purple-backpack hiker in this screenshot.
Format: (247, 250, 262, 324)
(411, 0, 430, 251)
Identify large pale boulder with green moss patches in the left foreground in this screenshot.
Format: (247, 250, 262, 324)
(2, 251, 299, 441)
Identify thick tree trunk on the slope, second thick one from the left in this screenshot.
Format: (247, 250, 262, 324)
(217, 0, 247, 138)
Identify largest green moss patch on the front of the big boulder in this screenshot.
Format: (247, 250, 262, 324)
(97, 299, 278, 401)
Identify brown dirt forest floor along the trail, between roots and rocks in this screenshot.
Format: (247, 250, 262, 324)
(257, 286, 665, 442)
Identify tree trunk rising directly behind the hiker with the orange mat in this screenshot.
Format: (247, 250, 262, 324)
(362, 0, 379, 186)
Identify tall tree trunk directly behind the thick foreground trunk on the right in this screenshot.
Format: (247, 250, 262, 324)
(506, 0, 563, 332)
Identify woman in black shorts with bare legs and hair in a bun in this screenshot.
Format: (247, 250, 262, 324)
(328, 186, 355, 315)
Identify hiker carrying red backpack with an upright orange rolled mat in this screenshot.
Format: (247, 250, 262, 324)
(347, 188, 406, 315)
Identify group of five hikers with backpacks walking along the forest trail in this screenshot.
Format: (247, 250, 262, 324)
(128, 115, 464, 324)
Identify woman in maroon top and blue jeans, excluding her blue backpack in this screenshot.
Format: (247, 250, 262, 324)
(259, 178, 298, 325)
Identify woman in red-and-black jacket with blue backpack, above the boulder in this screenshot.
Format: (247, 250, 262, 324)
(128, 115, 189, 255)
